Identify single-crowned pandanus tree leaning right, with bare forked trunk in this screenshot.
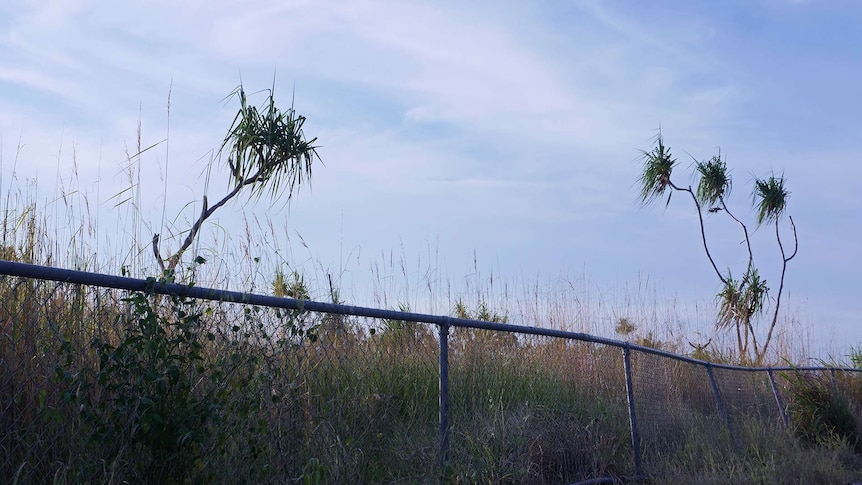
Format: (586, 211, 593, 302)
(153, 85, 319, 277)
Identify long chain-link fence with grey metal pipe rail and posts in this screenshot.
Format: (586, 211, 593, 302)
(0, 261, 862, 483)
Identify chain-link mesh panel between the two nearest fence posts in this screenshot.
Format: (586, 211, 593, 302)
(449, 328, 631, 483)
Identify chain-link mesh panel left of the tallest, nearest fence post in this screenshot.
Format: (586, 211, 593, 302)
(0, 277, 438, 483)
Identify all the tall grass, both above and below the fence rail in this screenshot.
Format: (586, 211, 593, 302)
(0, 126, 862, 484)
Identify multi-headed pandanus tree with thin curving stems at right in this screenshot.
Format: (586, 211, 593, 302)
(639, 132, 799, 364)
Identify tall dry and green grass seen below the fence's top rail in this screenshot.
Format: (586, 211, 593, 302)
(0, 255, 862, 483)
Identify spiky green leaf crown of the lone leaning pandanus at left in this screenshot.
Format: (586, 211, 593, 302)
(220, 85, 317, 199)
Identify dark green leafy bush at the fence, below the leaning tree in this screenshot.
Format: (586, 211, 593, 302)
(56, 282, 250, 483)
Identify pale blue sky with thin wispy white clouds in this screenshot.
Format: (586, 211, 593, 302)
(0, 0, 862, 354)
